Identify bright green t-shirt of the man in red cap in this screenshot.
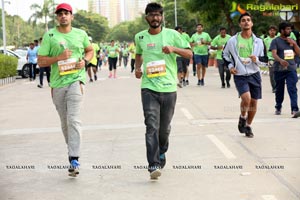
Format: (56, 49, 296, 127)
(38, 27, 90, 88)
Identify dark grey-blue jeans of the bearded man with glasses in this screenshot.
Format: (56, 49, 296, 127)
(142, 89, 177, 168)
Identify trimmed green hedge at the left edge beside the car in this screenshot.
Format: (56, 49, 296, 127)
(0, 54, 18, 79)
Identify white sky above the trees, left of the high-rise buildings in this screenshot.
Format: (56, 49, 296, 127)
(0, 0, 88, 21)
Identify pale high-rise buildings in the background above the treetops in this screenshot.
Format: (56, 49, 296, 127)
(88, 0, 150, 27)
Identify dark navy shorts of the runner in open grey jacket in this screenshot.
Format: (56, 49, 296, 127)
(234, 72, 262, 99)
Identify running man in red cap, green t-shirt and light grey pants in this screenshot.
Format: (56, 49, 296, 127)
(38, 3, 94, 176)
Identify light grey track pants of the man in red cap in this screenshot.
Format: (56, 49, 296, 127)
(52, 81, 84, 157)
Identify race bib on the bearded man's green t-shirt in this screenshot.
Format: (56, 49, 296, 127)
(146, 60, 167, 78)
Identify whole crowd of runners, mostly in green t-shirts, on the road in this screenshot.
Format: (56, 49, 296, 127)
(23, 3, 300, 179)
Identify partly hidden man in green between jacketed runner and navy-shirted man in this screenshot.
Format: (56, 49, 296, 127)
(264, 25, 277, 93)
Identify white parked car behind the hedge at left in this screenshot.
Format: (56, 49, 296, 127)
(0, 48, 39, 78)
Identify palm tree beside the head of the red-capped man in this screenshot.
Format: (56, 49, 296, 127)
(28, 0, 56, 31)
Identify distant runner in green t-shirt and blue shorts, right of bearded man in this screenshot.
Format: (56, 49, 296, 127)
(190, 24, 211, 86)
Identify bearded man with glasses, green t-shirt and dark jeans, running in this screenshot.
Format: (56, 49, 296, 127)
(135, 3, 192, 179)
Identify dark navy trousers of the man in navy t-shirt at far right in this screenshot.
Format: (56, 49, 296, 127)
(274, 70, 299, 111)
